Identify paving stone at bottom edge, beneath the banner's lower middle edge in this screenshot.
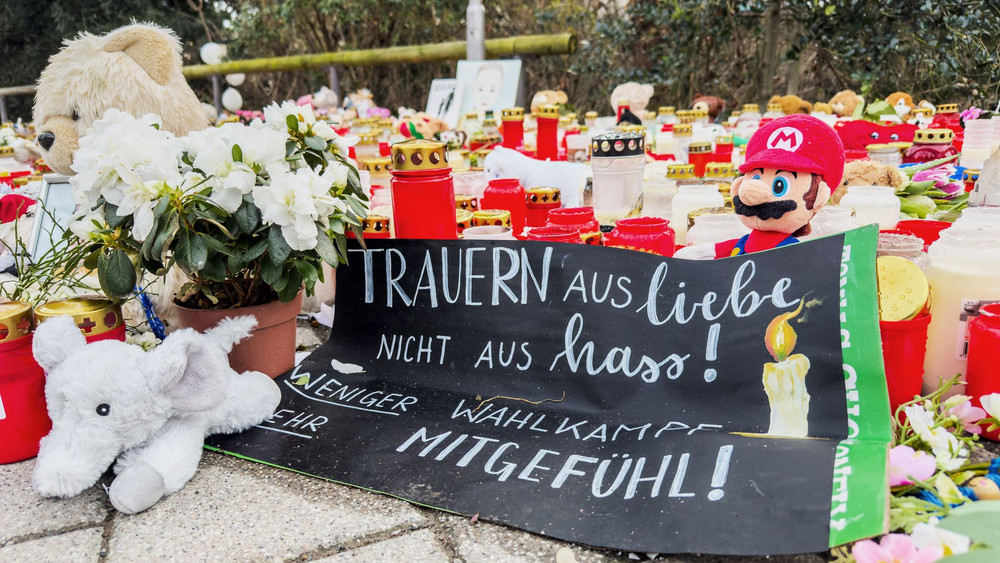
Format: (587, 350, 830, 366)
(435, 513, 624, 563)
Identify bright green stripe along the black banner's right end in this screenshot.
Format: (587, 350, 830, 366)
(830, 225, 892, 547)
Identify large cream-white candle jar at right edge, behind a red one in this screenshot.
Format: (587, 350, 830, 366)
(923, 226, 1000, 393)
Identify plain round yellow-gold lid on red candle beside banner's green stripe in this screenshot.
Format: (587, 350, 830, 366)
(875, 256, 930, 321)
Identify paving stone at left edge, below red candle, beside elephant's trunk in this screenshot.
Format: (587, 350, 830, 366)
(0, 459, 108, 545)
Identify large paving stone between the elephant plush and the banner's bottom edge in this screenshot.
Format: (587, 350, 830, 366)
(107, 452, 425, 562)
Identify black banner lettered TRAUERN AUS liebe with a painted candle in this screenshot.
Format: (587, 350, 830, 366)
(209, 231, 888, 554)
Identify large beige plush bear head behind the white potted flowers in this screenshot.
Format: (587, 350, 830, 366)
(34, 23, 208, 174)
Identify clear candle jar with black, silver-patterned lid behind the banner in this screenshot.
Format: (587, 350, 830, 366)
(590, 133, 646, 225)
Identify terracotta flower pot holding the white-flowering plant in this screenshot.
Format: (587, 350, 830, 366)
(176, 291, 302, 378)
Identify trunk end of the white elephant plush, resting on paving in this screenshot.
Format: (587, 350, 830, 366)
(32, 427, 121, 497)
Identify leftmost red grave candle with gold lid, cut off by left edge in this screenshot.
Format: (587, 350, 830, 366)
(0, 301, 52, 464)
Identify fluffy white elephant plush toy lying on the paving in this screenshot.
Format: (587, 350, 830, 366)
(32, 317, 281, 514)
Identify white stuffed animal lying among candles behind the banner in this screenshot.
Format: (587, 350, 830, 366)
(483, 147, 591, 207)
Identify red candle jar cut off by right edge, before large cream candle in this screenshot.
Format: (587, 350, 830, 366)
(965, 303, 1000, 442)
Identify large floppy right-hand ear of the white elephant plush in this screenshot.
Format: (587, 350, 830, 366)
(146, 331, 232, 413)
